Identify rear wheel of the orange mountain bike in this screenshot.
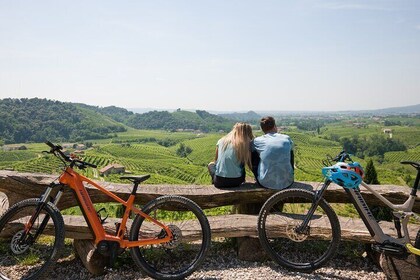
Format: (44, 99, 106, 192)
(130, 195, 211, 279)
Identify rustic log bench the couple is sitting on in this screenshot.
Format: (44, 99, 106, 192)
(0, 171, 420, 275)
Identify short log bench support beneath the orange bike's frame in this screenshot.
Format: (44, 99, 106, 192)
(73, 239, 108, 276)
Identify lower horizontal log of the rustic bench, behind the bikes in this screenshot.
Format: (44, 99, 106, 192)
(1, 214, 418, 243)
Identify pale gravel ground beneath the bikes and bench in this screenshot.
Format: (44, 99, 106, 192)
(44, 242, 386, 280)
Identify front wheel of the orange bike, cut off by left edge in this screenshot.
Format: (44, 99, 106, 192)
(0, 198, 64, 280)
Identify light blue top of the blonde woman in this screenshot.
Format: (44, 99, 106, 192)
(215, 139, 244, 178)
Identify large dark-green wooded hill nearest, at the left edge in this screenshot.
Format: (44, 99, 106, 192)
(0, 98, 126, 144)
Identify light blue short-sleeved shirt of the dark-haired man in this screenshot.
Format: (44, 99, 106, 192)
(252, 133, 294, 190)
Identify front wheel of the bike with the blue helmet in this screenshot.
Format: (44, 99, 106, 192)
(258, 189, 341, 272)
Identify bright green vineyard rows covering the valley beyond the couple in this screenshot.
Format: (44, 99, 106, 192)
(0, 118, 420, 185)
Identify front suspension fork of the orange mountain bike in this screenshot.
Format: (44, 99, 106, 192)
(21, 183, 64, 243)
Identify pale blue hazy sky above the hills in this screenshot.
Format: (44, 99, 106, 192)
(0, 0, 420, 111)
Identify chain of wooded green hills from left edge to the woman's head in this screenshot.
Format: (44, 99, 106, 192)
(0, 98, 233, 145)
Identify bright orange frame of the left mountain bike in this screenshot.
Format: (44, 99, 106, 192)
(59, 167, 172, 248)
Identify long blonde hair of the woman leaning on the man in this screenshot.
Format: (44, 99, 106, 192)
(222, 122, 254, 168)
